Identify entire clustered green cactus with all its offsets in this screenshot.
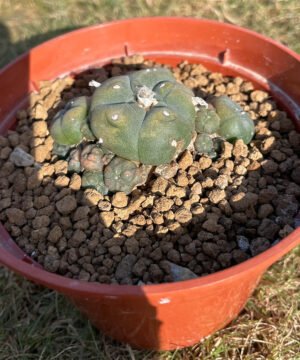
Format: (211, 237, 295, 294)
(50, 68, 254, 193)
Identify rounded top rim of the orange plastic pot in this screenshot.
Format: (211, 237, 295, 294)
(0, 16, 300, 297)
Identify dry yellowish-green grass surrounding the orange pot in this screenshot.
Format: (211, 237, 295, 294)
(0, 0, 300, 360)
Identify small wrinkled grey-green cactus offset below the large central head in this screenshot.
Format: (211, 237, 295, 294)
(104, 156, 149, 194)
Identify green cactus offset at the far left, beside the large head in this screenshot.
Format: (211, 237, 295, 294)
(50, 96, 89, 145)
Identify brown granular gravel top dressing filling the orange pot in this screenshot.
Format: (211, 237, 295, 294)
(0, 55, 300, 284)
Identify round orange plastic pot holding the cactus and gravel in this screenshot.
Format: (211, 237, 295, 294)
(0, 18, 300, 350)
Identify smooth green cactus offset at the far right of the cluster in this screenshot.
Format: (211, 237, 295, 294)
(211, 96, 254, 144)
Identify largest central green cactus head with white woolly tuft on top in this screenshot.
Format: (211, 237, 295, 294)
(90, 68, 196, 165)
